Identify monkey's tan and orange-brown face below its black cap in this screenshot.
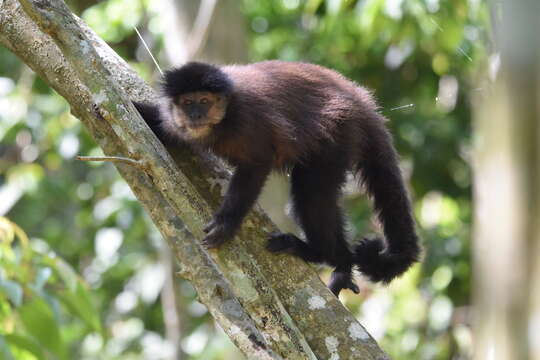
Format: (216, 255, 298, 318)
(172, 91, 227, 139)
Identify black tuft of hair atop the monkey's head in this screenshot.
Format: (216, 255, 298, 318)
(162, 62, 233, 98)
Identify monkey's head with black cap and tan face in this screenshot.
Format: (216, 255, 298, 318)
(163, 62, 232, 140)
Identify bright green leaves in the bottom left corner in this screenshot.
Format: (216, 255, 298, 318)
(0, 217, 102, 360)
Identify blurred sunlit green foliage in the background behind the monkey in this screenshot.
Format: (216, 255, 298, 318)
(0, 0, 488, 360)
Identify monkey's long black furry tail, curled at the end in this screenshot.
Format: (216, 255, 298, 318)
(353, 115, 421, 283)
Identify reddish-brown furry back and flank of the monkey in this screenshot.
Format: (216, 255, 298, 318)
(218, 61, 376, 167)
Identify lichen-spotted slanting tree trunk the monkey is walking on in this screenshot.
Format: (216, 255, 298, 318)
(0, 0, 387, 359)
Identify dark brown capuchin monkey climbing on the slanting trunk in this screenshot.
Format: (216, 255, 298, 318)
(135, 61, 421, 295)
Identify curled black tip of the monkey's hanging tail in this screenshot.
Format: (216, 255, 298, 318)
(354, 238, 421, 284)
